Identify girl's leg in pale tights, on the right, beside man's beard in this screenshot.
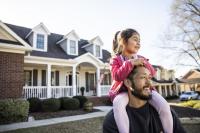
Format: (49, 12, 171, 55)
(149, 90, 173, 133)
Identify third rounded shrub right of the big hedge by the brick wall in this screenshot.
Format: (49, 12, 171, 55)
(62, 98, 80, 110)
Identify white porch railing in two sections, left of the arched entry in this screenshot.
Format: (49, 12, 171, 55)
(23, 86, 73, 99)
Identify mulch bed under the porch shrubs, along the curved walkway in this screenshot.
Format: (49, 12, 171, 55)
(29, 109, 100, 120)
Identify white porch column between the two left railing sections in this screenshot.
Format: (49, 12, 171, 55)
(47, 64, 51, 98)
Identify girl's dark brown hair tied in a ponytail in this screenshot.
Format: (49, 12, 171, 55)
(113, 28, 140, 55)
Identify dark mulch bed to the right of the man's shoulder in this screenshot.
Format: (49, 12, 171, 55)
(171, 105, 200, 118)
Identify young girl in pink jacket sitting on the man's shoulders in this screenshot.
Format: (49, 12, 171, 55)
(109, 29, 173, 133)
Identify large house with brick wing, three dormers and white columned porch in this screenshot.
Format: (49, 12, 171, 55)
(0, 21, 111, 99)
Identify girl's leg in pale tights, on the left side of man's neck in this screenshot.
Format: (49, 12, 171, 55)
(113, 92, 129, 133)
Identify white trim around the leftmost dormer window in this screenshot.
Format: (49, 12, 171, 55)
(33, 32, 48, 52)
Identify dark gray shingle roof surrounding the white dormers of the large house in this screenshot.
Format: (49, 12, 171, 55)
(5, 23, 111, 62)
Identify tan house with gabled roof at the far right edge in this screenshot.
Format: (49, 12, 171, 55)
(177, 69, 200, 92)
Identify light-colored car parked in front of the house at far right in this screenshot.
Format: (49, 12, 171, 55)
(179, 91, 199, 101)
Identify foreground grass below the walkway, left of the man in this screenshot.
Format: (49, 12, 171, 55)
(5, 117, 104, 133)
